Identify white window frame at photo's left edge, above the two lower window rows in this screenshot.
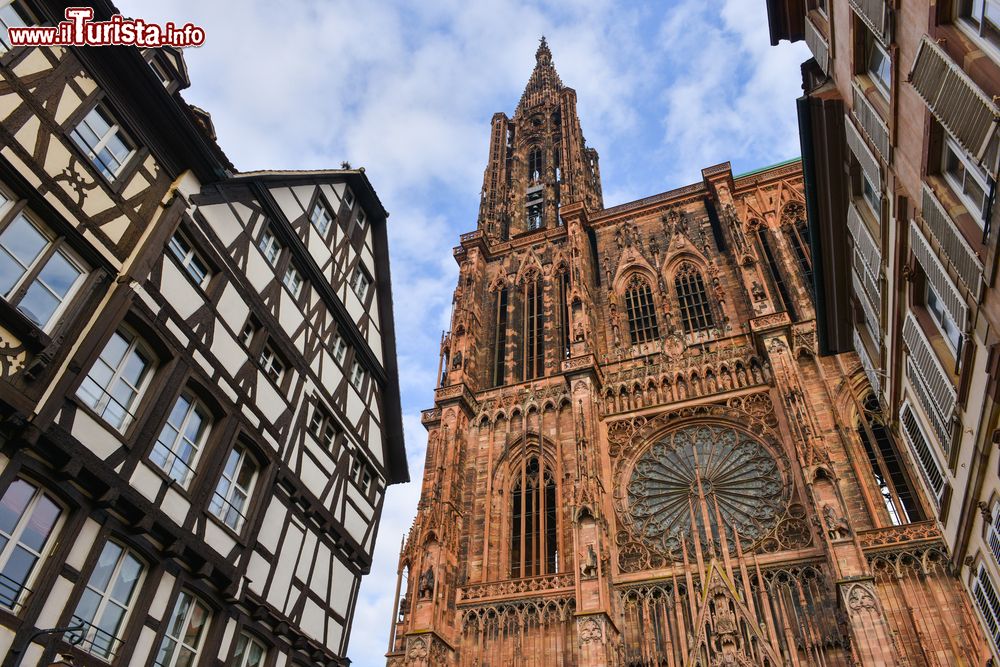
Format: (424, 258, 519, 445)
(0, 211, 87, 331)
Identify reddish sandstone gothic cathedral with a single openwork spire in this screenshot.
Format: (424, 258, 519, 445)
(387, 40, 989, 667)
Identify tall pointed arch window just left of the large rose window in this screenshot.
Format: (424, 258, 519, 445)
(510, 456, 558, 579)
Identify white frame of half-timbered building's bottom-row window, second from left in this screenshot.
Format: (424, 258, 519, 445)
(70, 540, 146, 660)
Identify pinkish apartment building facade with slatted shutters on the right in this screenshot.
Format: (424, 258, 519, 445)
(767, 0, 1000, 652)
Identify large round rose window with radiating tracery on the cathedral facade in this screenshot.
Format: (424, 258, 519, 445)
(628, 425, 787, 557)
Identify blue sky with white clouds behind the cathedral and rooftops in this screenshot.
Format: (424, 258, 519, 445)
(118, 0, 808, 667)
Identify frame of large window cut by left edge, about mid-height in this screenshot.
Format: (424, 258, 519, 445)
(0, 207, 91, 333)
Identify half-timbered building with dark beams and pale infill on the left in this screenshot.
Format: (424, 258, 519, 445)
(0, 0, 407, 667)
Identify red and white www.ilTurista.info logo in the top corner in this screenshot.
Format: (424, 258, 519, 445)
(8, 7, 205, 48)
